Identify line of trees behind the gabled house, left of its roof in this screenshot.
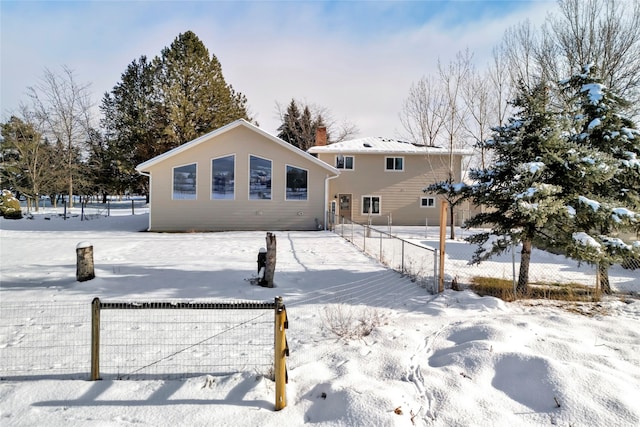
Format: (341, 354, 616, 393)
(0, 31, 251, 209)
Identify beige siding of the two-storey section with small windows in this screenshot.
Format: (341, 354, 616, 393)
(318, 153, 462, 225)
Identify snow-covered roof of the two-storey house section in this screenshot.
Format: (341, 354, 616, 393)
(308, 136, 472, 156)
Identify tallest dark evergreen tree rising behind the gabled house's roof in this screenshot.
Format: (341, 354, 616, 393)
(101, 31, 250, 197)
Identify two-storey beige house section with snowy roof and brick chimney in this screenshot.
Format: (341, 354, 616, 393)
(308, 129, 472, 225)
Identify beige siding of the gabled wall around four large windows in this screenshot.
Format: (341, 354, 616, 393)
(149, 126, 327, 231)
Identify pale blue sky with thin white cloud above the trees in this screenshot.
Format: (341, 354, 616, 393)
(0, 0, 556, 137)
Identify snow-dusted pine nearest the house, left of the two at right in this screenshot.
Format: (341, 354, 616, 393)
(462, 84, 571, 295)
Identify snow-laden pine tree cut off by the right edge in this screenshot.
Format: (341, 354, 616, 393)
(556, 66, 640, 293)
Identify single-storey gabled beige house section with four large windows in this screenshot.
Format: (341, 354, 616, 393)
(136, 119, 339, 231)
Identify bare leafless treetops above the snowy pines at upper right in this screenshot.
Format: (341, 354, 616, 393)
(500, 0, 640, 116)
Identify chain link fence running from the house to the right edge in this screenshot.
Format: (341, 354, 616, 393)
(328, 214, 640, 293)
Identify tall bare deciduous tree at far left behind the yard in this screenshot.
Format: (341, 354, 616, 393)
(28, 66, 92, 207)
